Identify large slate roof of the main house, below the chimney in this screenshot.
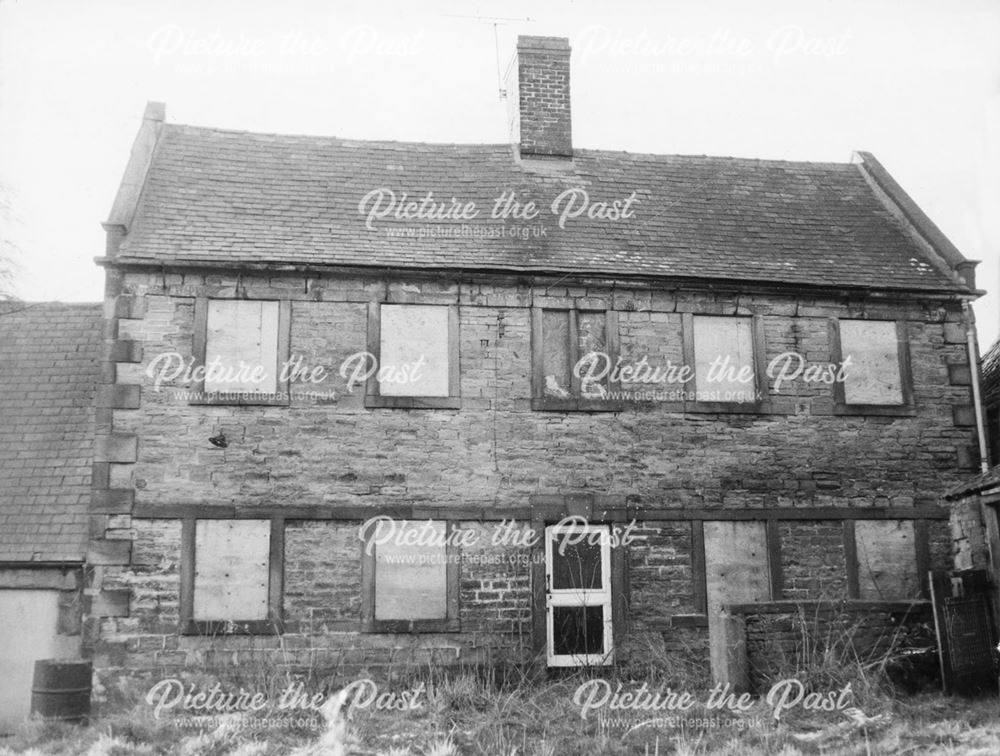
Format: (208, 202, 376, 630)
(118, 124, 968, 291)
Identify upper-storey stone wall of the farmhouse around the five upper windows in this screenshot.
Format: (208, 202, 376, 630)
(99, 274, 974, 507)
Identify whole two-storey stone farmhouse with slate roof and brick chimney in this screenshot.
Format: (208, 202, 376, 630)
(0, 37, 981, 708)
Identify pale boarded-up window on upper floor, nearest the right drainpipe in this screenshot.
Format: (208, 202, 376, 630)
(840, 320, 903, 404)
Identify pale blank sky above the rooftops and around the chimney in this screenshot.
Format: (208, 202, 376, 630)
(0, 0, 1000, 348)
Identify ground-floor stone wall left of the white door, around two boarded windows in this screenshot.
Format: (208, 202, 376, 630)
(94, 518, 532, 683)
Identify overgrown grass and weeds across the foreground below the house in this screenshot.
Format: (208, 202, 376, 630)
(0, 617, 1000, 756)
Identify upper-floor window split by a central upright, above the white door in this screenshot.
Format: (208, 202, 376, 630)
(541, 310, 611, 399)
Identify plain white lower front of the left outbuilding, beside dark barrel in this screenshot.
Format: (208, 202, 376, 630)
(0, 590, 72, 733)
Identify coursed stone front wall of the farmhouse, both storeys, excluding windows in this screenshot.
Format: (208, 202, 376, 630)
(86, 271, 974, 684)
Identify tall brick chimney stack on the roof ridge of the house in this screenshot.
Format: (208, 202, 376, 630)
(507, 37, 573, 158)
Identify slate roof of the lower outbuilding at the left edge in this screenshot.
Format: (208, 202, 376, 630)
(0, 303, 101, 562)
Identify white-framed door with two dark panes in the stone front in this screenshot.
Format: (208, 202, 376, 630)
(545, 524, 614, 667)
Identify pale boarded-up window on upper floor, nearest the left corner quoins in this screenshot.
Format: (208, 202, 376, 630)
(205, 299, 279, 393)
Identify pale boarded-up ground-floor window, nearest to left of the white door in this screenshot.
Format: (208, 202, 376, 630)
(375, 520, 448, 620)
